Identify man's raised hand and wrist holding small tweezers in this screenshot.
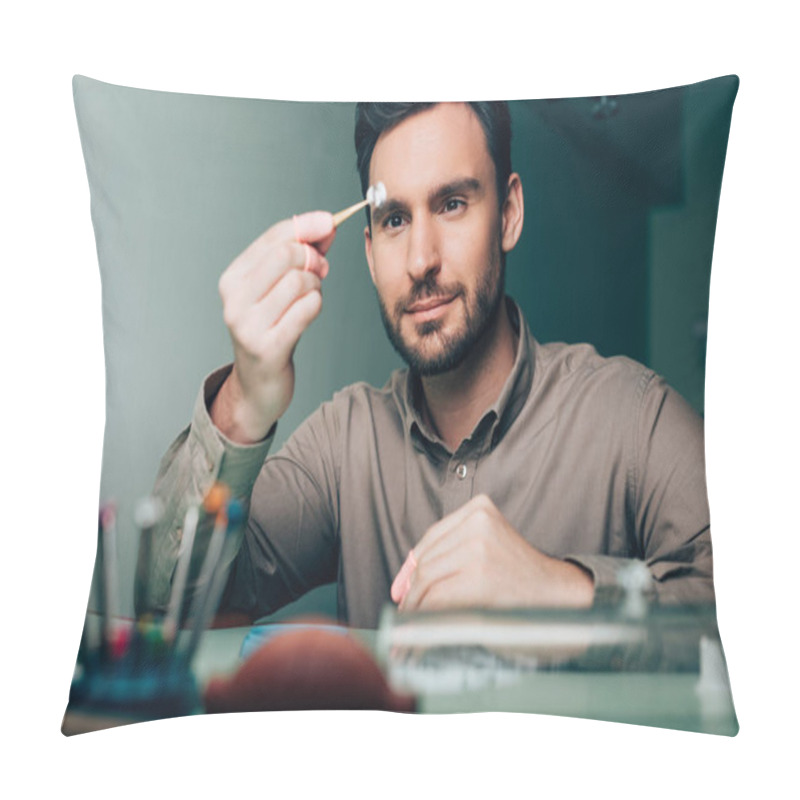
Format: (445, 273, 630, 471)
(210, 211, 336, 444)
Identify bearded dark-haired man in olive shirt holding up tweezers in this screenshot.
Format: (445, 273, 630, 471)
(151, 103, 713, 627)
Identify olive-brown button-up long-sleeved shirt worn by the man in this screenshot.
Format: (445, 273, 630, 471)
(150, 300, 714, 628)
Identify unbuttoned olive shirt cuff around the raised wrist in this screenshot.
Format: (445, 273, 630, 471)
(188, 364, 277, 499)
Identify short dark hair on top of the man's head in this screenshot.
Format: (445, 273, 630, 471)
(355, 101, 511, 205)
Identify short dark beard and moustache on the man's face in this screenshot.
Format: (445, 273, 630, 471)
(378, 253, 505, 376)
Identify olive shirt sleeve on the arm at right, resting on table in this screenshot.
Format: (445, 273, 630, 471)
(567, 374, 714, 604)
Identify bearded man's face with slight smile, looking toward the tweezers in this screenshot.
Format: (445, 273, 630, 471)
(365, 103, 516, 375)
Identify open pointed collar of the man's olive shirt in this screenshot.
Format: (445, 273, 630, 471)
(392, 297, 536, 450)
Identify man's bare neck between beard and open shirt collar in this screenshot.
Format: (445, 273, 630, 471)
(421, 302, 517, 452)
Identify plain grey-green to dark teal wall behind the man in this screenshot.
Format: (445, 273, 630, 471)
(74, 78, 736, 616)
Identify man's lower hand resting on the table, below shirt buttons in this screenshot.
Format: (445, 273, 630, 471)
(393, 495, 594, 611)
